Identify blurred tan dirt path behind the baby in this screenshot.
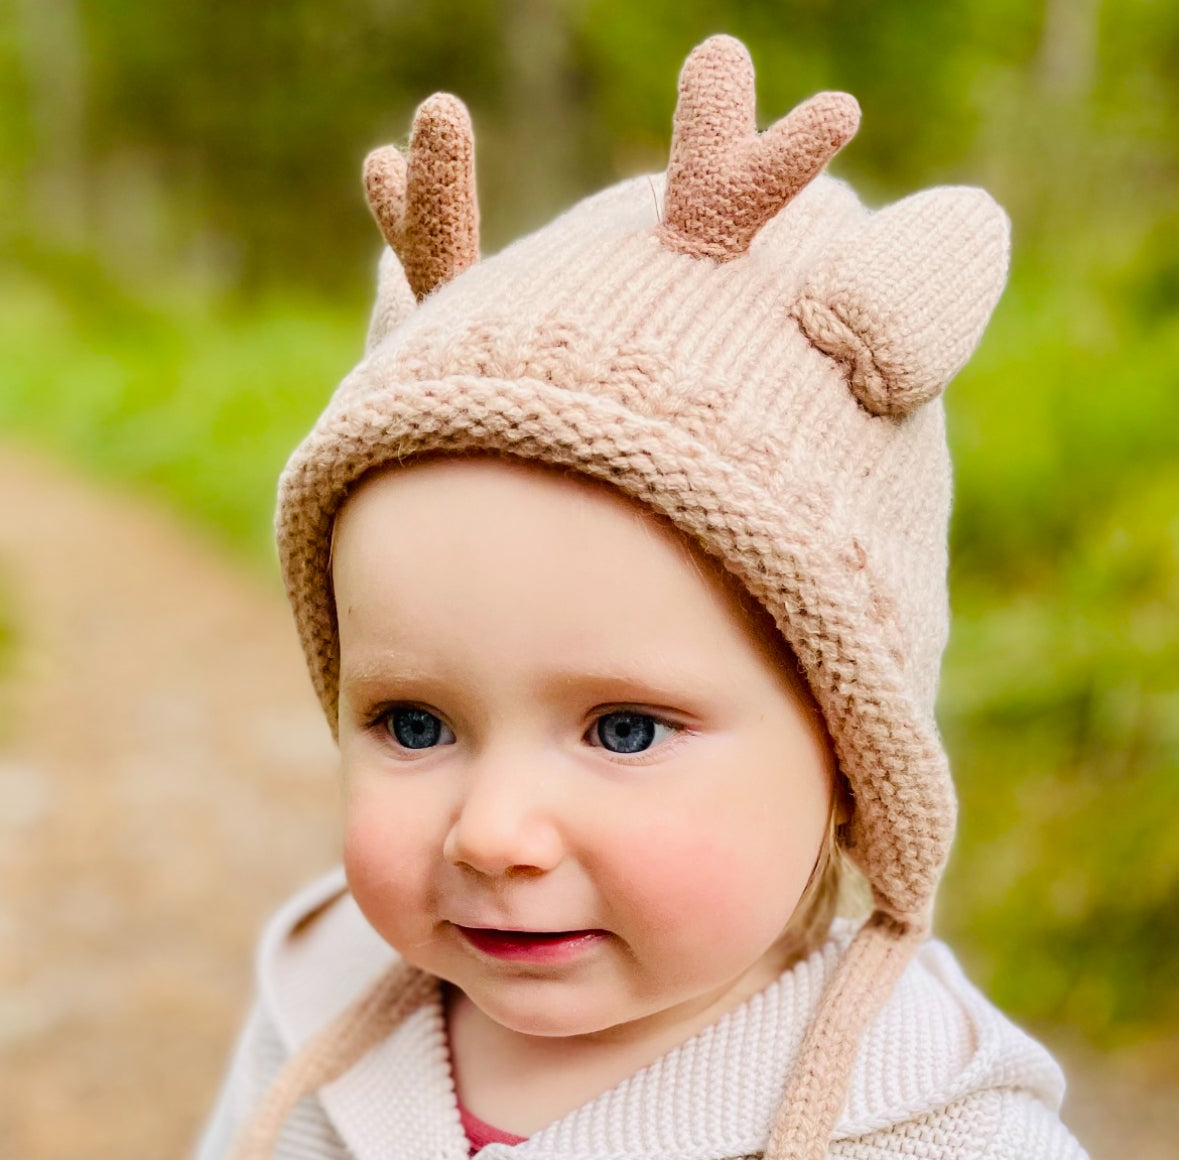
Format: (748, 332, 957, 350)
(0, 452, 1179, 1160)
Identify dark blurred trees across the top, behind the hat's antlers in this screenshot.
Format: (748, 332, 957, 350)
(0, 0, 1179, 288)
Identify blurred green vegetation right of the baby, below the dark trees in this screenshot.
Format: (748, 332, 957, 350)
(940, 248, 1179, 1043)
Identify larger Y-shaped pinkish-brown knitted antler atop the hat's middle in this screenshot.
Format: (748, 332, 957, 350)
(659, 37, 859, 261)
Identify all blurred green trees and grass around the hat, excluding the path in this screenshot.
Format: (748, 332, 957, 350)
(0, 0, 1179, 1043)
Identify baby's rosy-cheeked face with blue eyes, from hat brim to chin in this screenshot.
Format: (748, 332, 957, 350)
(334, 459, 832, 1036)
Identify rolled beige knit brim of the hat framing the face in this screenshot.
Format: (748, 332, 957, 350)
(277, 375, 955, 924)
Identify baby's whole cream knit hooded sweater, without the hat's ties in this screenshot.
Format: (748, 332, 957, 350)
(197, 872, 1085, 1160)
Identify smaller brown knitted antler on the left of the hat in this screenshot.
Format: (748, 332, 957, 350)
(364, 93, 479, 301)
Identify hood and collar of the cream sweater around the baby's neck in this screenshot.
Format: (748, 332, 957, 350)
(258, 871, 1065, 1160)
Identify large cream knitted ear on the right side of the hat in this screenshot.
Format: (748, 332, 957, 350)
(791, 186, 1009, 416)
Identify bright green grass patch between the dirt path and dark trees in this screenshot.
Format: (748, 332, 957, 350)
(0, 252, 363, 560)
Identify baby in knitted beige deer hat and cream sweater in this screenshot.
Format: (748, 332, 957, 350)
(199, 37, 1084, 1160)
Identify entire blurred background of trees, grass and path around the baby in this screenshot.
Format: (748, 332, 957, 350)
(0, 0, 1179, 1160)
